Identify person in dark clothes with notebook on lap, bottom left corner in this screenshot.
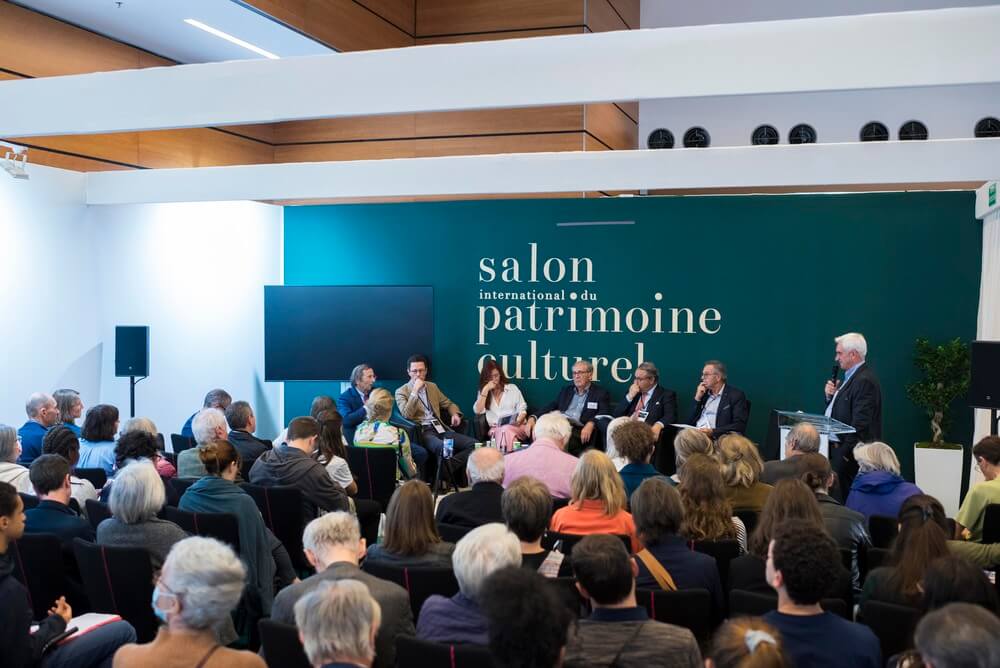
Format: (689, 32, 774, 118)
(0, 482, 135, 668)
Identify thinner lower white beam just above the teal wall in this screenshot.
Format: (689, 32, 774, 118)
(87, 139, 1000, 204)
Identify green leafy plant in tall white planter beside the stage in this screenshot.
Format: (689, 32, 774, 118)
(906, 338, 971, 517)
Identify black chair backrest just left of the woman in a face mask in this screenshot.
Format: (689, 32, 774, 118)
(73, 538, 159, 643)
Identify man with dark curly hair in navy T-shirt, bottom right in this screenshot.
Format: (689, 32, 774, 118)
(764, 520, 883, 668)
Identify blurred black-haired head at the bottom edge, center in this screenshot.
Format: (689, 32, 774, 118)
(480, 567, 573, 668)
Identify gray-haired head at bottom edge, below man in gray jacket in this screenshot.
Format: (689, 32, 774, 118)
(295, 579, 382, 668)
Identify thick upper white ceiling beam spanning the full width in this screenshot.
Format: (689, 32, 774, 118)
(0, 6, 1000, 137)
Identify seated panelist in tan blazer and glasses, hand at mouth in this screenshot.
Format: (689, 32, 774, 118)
(396, 355, 476, 468)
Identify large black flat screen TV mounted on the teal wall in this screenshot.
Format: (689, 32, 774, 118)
(264, 285, 434, 381)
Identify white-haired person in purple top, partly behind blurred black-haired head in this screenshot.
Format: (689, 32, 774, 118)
(417, 524, 521, 645)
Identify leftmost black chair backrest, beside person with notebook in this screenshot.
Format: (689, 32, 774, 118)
(9, 533, 67, 619)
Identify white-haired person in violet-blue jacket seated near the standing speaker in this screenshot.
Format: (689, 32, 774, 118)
(844, 441, 923, 519)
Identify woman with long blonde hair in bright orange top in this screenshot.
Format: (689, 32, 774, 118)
(549, 450, 642, 552)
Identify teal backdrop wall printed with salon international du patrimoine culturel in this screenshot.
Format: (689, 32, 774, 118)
(284, 192, 981, 476)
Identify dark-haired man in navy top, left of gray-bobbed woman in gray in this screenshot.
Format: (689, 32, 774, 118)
(24, 455, 94, 552)
